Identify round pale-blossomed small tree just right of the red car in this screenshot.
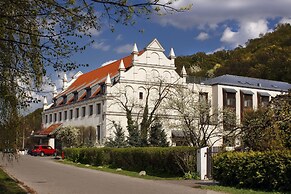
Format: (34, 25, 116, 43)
(56, 126, 81, 147)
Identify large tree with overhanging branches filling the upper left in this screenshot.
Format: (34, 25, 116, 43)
(0, 0, 187, 150)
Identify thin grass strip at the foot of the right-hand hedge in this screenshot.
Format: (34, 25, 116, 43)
(200, 185, 286, 194)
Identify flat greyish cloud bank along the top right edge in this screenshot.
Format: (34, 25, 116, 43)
(154, 0, 291, 29)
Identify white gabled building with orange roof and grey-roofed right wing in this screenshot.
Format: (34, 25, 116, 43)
(38, 39, 291, 146)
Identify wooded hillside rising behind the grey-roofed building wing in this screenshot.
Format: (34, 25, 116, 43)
(176, 24, 291, 83)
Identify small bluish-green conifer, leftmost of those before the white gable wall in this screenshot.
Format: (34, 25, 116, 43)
(105, 121, 127, 148)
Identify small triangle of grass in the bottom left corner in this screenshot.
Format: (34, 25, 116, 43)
(0, 168, 26, 194)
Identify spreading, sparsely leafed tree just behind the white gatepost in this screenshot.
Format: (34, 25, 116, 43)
(167, 86, 238, 148)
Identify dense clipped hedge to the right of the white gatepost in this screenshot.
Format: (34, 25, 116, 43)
(213, 150, 291, 191)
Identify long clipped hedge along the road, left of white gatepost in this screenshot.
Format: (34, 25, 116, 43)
(64, 147, 196, 176)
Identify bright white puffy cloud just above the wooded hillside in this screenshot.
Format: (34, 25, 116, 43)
(220, 20, 271, 47)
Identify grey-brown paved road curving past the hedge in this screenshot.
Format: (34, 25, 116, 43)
(0, 155, 221, 194)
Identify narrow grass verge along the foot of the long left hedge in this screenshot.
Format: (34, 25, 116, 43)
(59, 160, 182, 180)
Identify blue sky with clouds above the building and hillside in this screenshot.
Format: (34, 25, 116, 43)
(26, 0, 291, 113)
